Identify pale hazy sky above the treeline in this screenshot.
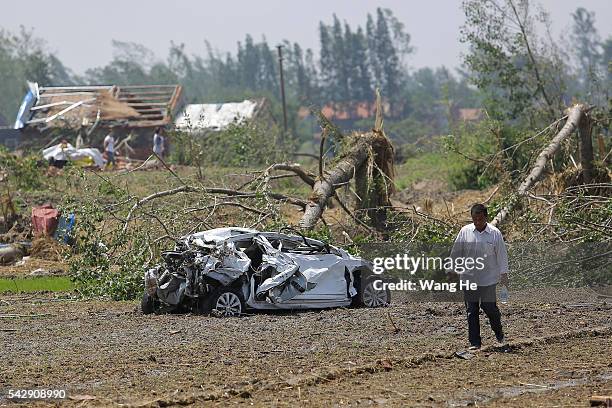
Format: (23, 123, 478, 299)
(0, 0, 612, 73)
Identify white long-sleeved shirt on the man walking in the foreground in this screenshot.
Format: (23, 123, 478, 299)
(451, 223, 508, 286)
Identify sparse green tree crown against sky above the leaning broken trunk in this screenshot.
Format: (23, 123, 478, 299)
(461, 0, 567, 121)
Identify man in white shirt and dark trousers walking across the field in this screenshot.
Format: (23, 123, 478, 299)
(451, 204, 508, 350)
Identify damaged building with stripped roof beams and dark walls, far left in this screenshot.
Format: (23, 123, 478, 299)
(14, 83, 182, 158)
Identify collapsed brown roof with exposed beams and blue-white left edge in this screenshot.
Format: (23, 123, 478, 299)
(15, 83, 182, 128)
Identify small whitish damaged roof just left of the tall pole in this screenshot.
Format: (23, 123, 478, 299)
(174, 98, 265, 131)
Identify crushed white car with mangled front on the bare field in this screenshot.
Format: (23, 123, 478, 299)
(141, 228, 391, 316)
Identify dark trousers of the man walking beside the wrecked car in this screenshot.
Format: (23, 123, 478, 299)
(463, 285, 504, 347)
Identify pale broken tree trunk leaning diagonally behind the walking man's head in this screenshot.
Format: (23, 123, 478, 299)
(491, 105, 588, 226)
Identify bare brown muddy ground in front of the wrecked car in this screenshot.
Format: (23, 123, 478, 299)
(0, 289, 612, 407)
